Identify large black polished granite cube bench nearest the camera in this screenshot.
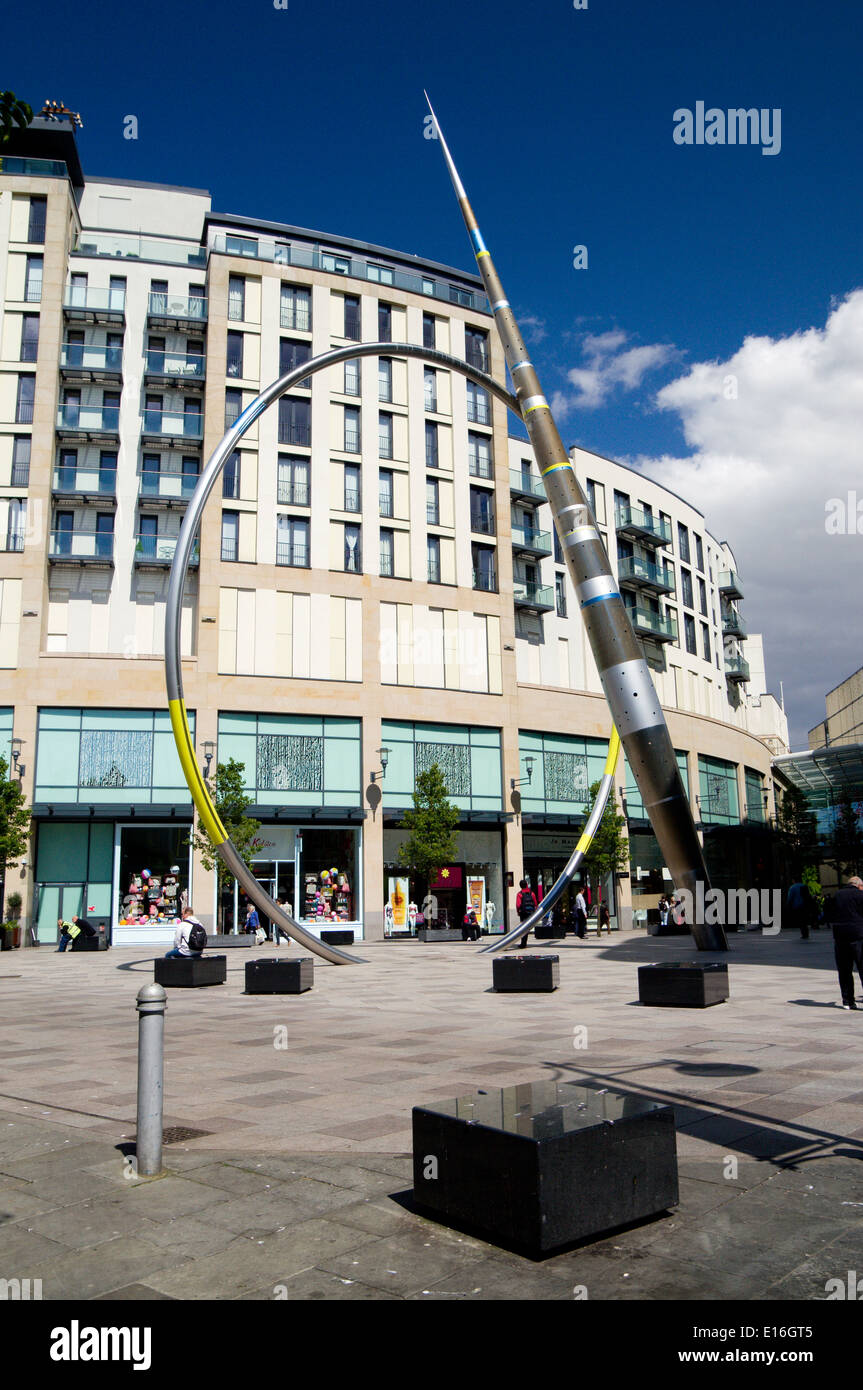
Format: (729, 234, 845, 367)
(413, 1081, 678, 1255)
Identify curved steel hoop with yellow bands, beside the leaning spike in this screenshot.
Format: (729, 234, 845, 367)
(165, 343, 617, 965)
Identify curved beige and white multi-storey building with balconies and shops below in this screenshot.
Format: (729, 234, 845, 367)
(0, 121, 787, 944)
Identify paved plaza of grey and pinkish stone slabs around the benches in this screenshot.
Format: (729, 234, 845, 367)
(0, 931, 863, 1301)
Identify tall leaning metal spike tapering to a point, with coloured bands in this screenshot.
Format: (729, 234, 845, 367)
(425, 93, 728, 951)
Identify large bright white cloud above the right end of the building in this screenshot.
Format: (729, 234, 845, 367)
(632, 289, 863, 748)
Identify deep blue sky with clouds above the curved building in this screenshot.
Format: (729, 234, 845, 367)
(6, 0, 863, 745)
